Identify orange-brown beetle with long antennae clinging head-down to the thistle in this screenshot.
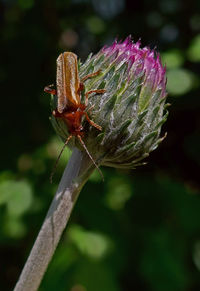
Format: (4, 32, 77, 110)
(44, 52, 106, 181)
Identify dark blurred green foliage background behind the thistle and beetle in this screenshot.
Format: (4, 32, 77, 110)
(0, 0, 200, 291)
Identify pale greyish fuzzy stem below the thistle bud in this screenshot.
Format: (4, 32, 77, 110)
(14, 149, 94, 291)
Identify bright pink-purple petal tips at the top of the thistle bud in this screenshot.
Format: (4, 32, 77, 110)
(102, 36, 166, 96)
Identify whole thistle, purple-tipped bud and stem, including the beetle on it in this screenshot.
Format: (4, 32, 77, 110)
(14, 37, 167, 291)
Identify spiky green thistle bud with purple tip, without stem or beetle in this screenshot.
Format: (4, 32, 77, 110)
(52, 37, 167, 169)
